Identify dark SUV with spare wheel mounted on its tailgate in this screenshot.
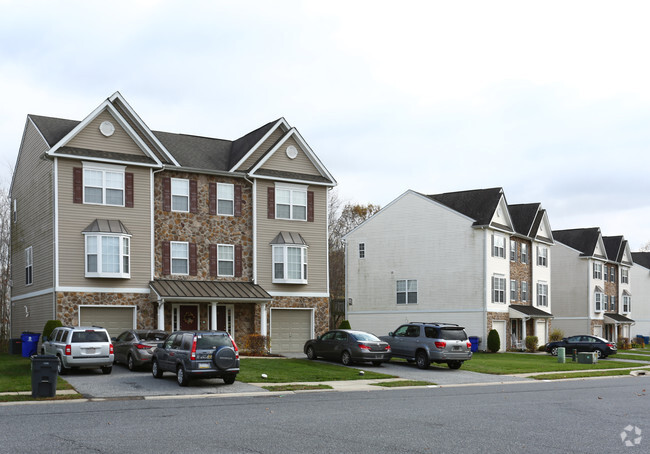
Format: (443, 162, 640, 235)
(151, 331, 239, 386)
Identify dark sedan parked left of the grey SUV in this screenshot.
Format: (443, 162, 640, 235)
(304, 329, 391, 366)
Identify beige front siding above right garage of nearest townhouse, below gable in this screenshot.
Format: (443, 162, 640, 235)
(256, 180, 329, 294)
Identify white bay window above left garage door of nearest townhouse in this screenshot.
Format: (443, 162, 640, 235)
(86, 235, 131, 278)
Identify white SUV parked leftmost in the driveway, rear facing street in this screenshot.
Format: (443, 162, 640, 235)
(41, 326, 114, 375)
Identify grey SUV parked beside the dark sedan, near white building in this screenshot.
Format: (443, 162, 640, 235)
(379, 322, 472, 369)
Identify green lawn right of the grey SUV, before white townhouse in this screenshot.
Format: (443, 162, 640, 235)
(462, 352, 647, 375)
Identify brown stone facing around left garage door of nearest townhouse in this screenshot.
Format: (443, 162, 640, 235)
(56, 292, 157, 329)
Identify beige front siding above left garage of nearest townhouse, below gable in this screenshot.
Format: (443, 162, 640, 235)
(59, 159, 151, 288)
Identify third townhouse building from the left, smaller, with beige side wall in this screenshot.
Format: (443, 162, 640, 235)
(552, 227, 634, 342)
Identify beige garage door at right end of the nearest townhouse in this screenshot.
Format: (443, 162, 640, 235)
(271, 309, 312, 353)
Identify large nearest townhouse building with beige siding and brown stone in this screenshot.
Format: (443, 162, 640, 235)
(11, 92, 336, 352)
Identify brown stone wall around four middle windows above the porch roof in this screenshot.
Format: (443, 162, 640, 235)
(154, 171, 253, 282)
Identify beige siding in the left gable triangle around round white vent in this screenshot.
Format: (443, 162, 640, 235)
(67, 111, 144, 155)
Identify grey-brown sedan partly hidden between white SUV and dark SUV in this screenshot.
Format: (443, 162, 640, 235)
(113, 329, 169, 370)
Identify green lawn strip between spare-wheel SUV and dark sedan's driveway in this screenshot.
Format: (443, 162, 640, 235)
(237, 358, 393, 383)
